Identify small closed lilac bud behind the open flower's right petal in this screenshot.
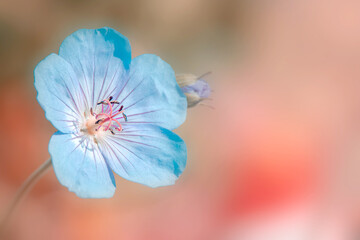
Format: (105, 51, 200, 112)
(176, 73, 211, 108)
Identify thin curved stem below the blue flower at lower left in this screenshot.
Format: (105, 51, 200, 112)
(0, 158, 52, 235)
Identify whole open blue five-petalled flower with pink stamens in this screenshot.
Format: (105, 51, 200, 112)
(34, 27, 187, 198)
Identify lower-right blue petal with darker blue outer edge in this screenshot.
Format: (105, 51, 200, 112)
(99, 124, 187, 187)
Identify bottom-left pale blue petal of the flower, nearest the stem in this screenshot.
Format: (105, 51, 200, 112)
(49, 132, 115, 198)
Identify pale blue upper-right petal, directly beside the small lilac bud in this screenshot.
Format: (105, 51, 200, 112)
(115, 54, 187, 130)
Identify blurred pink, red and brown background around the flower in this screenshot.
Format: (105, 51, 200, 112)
(0, 0, 360, 240)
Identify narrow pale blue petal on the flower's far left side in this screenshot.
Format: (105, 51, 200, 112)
(34, 54, 83, 132)
